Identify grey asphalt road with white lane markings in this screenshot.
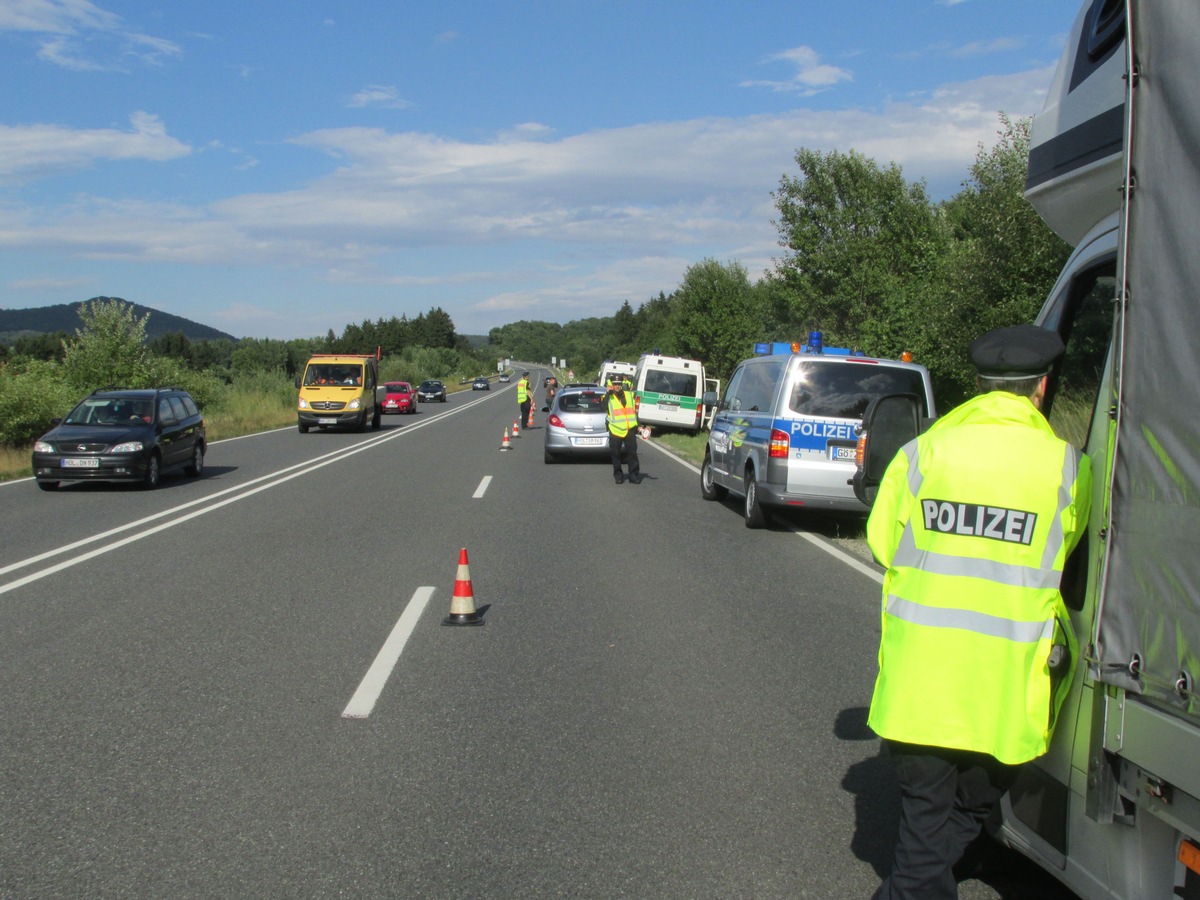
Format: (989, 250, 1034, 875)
(0, 370, 1063, 900)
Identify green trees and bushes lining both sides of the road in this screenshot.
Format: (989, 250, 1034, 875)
(0, 115, 1070, 479)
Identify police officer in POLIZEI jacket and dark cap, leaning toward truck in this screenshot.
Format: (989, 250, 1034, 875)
(866, 325, 1092, 900)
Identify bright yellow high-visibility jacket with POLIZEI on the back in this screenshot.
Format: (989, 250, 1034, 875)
(866, 391, 1091, 764)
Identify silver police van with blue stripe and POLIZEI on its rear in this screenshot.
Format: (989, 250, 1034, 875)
(701, 332, 935, 528)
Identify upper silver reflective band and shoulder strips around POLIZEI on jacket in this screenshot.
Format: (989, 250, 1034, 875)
(892, 444, 1080, 589)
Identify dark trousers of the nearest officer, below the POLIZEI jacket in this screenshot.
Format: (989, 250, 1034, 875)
(872, 740, 1020, 900)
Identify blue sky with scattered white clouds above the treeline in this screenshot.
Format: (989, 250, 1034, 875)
(0, 0, 1079, 338)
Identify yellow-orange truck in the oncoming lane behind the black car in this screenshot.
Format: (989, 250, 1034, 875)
(296, 352, 383, 434)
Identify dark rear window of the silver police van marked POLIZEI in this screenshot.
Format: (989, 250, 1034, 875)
(788, 362, 925, 419)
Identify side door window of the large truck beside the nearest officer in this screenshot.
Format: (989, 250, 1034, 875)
(1042, 259, 1116, 450)
